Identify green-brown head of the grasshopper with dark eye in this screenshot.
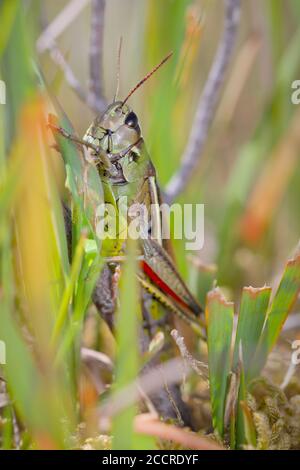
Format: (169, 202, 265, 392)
(83, 101, 141, 157)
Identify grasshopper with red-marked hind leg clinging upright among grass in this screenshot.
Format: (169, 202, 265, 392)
(51, 54, 203, 333)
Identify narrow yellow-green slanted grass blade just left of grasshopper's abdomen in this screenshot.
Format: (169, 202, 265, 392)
(51, 235, 86, 344)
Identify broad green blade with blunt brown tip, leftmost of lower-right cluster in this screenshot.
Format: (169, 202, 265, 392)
(205, 289, 234, 437)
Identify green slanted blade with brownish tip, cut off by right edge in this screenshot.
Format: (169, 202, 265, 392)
(253, 254, 300, 376)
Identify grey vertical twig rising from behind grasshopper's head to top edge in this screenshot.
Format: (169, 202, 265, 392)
(89, 0, 106, 113)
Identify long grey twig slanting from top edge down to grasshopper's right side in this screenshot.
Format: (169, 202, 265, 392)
(166, 0, 241, 202)
